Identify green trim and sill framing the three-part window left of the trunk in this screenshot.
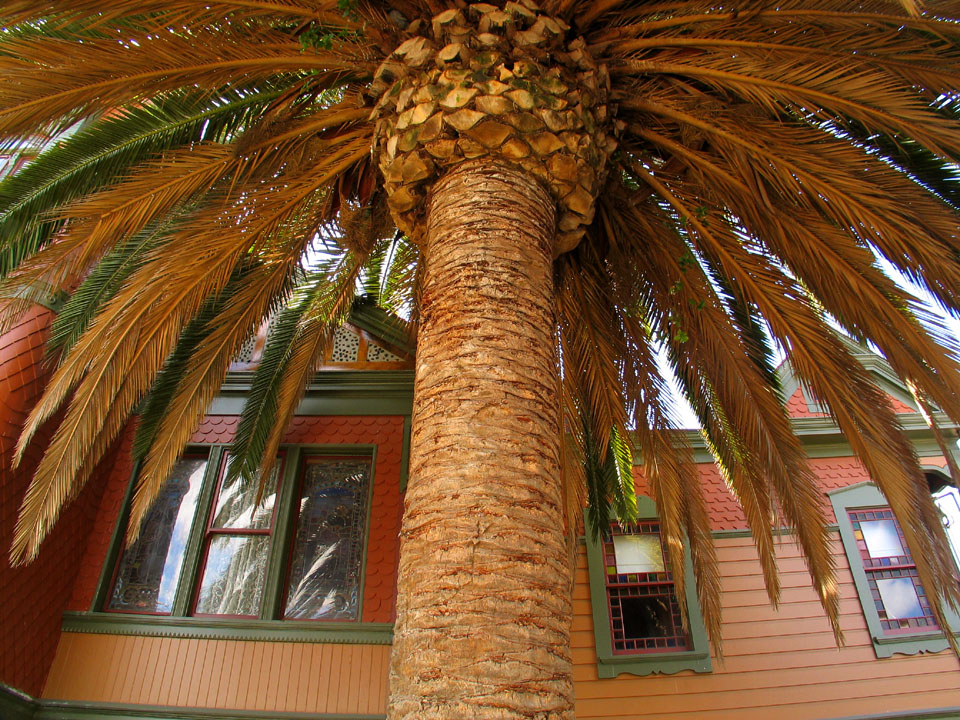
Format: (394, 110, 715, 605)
(85, 444, 393, 645)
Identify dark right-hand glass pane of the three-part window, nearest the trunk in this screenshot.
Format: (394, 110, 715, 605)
(284, 458, 370, 620)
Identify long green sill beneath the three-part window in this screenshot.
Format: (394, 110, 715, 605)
(61, 612, 393, 645)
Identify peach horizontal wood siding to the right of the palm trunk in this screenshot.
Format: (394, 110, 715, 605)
(573, 536, 960, 720)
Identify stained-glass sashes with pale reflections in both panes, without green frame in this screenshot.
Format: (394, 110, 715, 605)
(848, 508, 939, 635)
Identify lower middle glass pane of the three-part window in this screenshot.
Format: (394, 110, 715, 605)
(195, 535, 270, 616)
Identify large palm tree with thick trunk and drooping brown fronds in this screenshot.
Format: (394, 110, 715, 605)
(0, 0, 960, 718)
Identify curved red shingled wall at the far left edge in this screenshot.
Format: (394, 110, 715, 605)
(0, 308, 112, 695)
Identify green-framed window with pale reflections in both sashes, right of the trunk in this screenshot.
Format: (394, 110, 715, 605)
(830, 483, 960, 657)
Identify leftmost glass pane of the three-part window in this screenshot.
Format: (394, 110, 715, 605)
(107, 458, 207, 613)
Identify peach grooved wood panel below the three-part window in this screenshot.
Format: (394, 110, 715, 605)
(43, 633, 390, 714)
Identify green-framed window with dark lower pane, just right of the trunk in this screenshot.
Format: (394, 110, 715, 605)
(587, 498, 711, 678)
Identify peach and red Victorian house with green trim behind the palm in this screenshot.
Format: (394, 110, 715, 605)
(0, 307, 960, 720)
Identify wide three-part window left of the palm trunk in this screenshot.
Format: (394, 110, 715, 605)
(102, 447, 373, 622)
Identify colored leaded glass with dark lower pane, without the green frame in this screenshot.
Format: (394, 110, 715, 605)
(602, 520, 691, 654)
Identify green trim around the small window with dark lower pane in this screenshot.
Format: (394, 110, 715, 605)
(586, 496, 713, 678)
